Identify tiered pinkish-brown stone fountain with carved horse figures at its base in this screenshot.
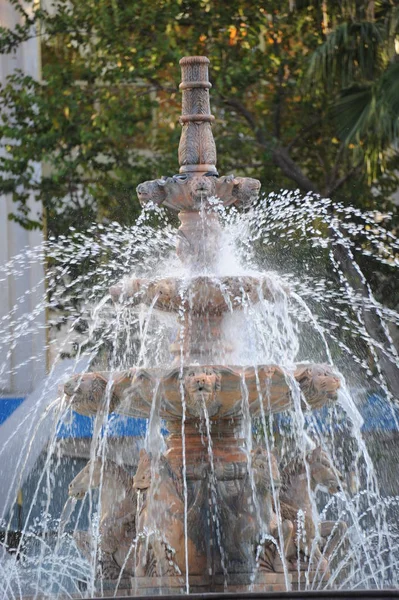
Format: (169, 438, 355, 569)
(64, 56, 345, 594)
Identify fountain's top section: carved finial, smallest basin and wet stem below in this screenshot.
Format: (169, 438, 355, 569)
(137, 56, 260, 216)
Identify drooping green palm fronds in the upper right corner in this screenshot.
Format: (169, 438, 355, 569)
(307, 0, 399, 185)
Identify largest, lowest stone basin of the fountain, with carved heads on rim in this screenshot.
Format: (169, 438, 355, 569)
(64, 364, 340, 420)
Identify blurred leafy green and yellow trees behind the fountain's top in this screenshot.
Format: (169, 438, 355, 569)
(0, 0, 399, 236)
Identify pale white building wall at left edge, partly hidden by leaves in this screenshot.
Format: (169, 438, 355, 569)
(0, 0, 46, 395)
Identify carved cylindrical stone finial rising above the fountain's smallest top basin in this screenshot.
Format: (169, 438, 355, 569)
(179, 56, 217, 175)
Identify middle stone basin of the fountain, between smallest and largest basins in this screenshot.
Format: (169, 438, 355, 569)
(109, 275, 287, 315)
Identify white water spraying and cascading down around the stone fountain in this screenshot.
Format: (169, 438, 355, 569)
(0, 192, 399, 599)
